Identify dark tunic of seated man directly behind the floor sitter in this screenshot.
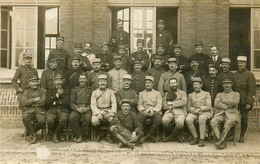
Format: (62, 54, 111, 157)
(116, 88, 137, 112)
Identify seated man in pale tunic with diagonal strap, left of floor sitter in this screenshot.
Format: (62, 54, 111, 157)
(91, 75, 117, 142)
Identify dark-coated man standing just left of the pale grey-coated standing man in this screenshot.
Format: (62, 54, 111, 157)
(146, 55, 165, 90)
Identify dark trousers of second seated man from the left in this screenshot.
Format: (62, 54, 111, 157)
(46, 108, 69, 134)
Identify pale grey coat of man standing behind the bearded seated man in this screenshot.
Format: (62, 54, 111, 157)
(158, 71, 187, 96)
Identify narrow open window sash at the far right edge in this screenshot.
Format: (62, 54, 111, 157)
(251, 8, 260, 71)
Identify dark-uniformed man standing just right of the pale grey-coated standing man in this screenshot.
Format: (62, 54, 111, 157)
(184, 58, 207, 94)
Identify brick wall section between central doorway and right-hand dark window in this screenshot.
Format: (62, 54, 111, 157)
(179, 0, 229, 57)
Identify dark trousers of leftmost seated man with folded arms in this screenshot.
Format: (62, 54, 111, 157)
(22, 110, 45, 134)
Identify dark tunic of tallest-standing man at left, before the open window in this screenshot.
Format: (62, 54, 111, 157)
(48, 48, 70, 70)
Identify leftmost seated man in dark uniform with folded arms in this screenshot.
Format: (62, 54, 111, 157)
(22, 74, 46, 144)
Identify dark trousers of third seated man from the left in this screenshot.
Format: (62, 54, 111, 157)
(69, 110, 92, 137)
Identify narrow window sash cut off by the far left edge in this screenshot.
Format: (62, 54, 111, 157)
(0, 8, 10, 68)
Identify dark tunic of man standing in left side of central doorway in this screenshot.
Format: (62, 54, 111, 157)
(110, 30, 130, 53)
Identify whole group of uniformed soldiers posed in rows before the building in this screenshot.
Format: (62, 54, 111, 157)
(12, 18, 256, 149)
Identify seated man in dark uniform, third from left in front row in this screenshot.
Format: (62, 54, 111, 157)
(69, 72, 92, 143)
